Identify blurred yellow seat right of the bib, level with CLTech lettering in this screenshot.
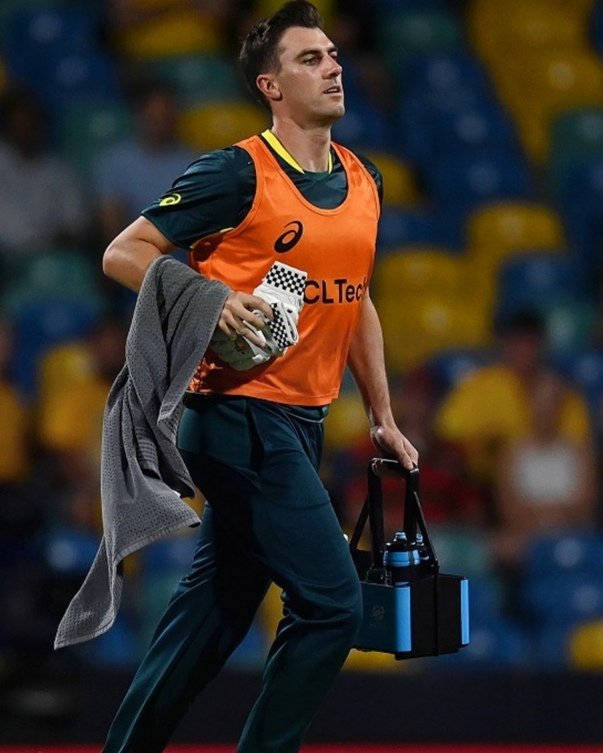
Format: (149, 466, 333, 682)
(372, 246, 465, 299)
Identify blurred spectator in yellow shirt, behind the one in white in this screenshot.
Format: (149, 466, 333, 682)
(435, 311, 591, 485)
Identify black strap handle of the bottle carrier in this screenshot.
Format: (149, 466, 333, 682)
(350, 458, 440, 574)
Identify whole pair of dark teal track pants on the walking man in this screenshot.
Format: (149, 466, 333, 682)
(104, 396, 362, 753)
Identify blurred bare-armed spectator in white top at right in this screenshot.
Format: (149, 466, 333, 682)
(495, 372, 598, 567)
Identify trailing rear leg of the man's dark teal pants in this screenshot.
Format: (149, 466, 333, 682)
(103, 494, 270, 753)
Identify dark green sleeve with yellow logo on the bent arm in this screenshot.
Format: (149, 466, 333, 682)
(142, 146, 255, 249)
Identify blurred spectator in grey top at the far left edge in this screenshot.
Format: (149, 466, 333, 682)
(0, 89, 88, 257)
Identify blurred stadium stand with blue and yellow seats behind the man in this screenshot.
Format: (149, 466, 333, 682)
(0, 0, 603, 744)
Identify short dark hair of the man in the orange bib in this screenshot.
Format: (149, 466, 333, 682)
(239, 0, 324, 106)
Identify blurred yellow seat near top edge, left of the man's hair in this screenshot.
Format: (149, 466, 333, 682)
(114, 9, 223, 58)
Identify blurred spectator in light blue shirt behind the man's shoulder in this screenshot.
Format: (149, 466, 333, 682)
(94, 82, 197, 245)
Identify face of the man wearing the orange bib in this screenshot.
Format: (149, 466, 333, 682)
(271, 26, 345, 127)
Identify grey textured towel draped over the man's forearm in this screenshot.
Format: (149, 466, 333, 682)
(55, 256, 230, 648)
